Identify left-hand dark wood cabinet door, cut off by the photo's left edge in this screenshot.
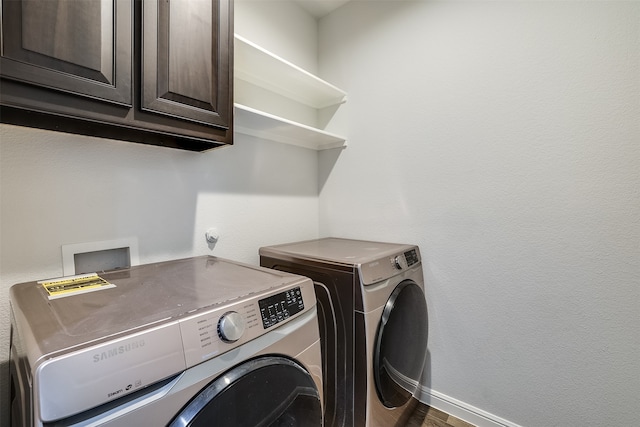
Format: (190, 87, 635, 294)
(0, 0, 133, 106)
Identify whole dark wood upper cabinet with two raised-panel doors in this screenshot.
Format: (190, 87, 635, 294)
(0, 0, 233, 151)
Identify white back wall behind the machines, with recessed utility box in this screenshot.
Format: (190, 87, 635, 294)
(0, 2, 318, 426)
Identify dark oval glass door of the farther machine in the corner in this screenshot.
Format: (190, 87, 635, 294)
(373, 280, 428, 408)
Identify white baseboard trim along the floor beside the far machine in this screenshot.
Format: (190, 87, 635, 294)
(417, 387, 522, 427)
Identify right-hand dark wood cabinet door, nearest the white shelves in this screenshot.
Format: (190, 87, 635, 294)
(141, 0, 233, 129)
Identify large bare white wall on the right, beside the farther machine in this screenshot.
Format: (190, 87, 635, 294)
(319, 1, 640, 426)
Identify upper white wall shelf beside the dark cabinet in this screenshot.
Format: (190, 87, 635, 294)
(234, 34, 347, 108)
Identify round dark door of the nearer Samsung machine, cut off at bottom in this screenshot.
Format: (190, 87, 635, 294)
(170, 356, 322, 427)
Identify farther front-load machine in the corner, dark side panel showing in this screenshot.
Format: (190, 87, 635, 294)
(260, 238, 428, 427)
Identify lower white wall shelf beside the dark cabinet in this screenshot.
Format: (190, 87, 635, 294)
(234, 104, 346, 150)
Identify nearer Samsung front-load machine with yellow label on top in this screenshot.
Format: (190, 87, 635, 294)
(10, 257, 322, 427)
